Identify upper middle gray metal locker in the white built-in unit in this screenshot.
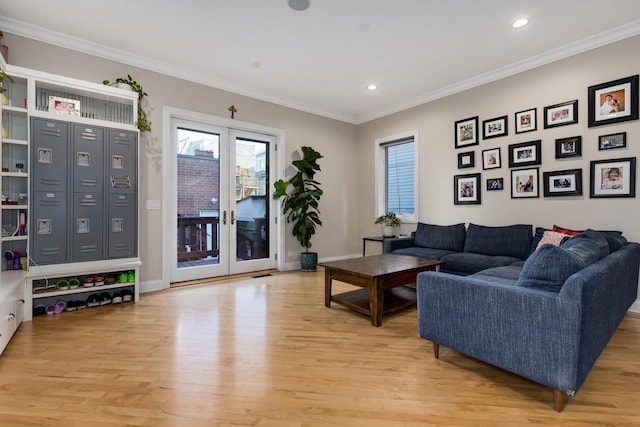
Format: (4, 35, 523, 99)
(70, 124, 105, 193)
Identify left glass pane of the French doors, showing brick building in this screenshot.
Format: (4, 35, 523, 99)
(176, 128, 220, 268)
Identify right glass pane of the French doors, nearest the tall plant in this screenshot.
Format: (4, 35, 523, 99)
(235, 138, 269, 261)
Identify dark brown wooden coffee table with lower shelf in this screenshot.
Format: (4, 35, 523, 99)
(318, 254, 445, 326)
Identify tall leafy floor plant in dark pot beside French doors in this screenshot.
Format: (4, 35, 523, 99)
(273, 147, 324, 271)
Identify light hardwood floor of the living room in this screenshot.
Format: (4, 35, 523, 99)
(0, 270, 640, 427)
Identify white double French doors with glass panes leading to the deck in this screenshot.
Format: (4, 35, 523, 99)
(171, 118, 276, 283)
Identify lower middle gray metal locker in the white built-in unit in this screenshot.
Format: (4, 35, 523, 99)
(70, 193, 104, 262)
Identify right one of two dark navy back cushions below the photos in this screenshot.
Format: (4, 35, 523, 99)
(464, 224, 533, 259)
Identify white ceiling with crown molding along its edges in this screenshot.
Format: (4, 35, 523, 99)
(0, 0, 640, 124)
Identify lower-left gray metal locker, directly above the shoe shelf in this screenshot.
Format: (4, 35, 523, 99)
(29, 191, 69, 265)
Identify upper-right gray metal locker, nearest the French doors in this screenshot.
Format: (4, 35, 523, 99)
(106, 129, 138, 194)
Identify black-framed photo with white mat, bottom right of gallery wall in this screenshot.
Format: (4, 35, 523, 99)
(589, 157, 636, 198)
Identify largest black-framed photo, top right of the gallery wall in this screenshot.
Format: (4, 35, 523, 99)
(587, 74, 638, 127)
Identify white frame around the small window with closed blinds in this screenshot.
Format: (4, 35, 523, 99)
(374, 130, 420, 224)
